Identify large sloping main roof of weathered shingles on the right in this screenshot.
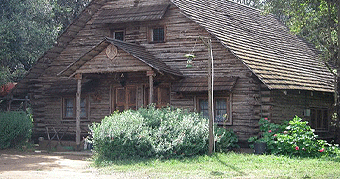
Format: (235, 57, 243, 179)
(171, 0, 334, 92)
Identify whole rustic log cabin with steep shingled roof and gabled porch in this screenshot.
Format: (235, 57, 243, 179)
(8, 0, 334, 146)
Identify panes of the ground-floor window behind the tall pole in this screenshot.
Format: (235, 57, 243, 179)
(198, 98, 232, 125)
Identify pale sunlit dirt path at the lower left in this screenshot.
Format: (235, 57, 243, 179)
(0, 150, 121, 179)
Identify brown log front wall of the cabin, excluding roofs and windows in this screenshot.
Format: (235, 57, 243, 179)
(27, 0, 328, 141)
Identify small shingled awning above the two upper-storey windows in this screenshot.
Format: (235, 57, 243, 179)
(93, 4, 169, 24)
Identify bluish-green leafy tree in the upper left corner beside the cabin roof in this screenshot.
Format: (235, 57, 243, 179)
(0, 0, 58, 72)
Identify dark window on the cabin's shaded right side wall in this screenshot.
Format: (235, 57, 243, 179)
(310, 108, 329, 131)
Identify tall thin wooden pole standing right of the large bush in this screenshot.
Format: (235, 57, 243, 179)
(200, 37, 215, 155)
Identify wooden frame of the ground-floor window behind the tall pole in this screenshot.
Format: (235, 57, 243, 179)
(196, 93, 233, 125)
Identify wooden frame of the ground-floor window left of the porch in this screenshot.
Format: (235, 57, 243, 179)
(62, 96, 89, 120)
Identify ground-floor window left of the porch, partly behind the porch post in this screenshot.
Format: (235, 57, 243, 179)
(63, 97, 87, 119)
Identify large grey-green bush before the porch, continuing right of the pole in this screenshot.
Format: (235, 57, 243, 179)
(90, 106, 237, 159)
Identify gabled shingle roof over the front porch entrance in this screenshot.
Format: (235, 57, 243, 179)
(58, 37, 183, 76)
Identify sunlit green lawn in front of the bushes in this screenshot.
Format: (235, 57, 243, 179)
(91, 152, 340, 179)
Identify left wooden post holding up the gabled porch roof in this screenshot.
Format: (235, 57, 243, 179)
(75, 74, 82, 150)
